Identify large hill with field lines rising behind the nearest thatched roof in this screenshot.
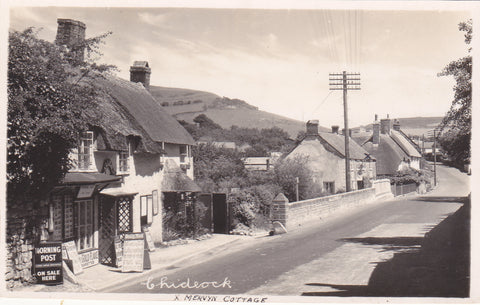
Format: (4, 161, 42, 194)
(150, 86, 329, 138)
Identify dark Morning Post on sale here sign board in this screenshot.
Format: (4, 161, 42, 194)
(33, 242, 63, 285)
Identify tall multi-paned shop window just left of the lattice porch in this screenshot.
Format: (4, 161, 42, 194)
(75, 200, 94, 251)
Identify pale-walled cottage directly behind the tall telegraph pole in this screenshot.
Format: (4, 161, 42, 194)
(286, 120, 376, 194)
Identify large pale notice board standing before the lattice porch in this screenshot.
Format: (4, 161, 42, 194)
(122, 233, 145, 272)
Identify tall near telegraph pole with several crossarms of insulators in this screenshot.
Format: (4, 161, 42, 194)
(329, 71, 360, 192)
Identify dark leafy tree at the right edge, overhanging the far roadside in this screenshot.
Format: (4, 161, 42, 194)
(439, 19, 472, 167)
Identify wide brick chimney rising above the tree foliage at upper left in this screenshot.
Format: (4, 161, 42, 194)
(55, 18, 86, 62)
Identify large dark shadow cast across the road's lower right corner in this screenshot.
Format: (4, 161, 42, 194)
(302, 198, 471, 298)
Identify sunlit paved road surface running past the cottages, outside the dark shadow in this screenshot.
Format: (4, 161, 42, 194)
(109, 166, 470, 295)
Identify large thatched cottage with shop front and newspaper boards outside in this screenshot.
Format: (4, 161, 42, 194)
(47, 19, 200, 267)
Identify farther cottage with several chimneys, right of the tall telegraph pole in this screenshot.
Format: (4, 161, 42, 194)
(353, 115, 422, 176)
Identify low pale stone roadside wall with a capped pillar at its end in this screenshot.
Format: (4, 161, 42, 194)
(272, 187, 376, 230)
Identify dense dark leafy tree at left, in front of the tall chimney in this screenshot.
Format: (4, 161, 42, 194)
(7, 28, 111, 206)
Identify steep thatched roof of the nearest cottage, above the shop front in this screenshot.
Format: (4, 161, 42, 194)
(85, 75, 194, 153)
